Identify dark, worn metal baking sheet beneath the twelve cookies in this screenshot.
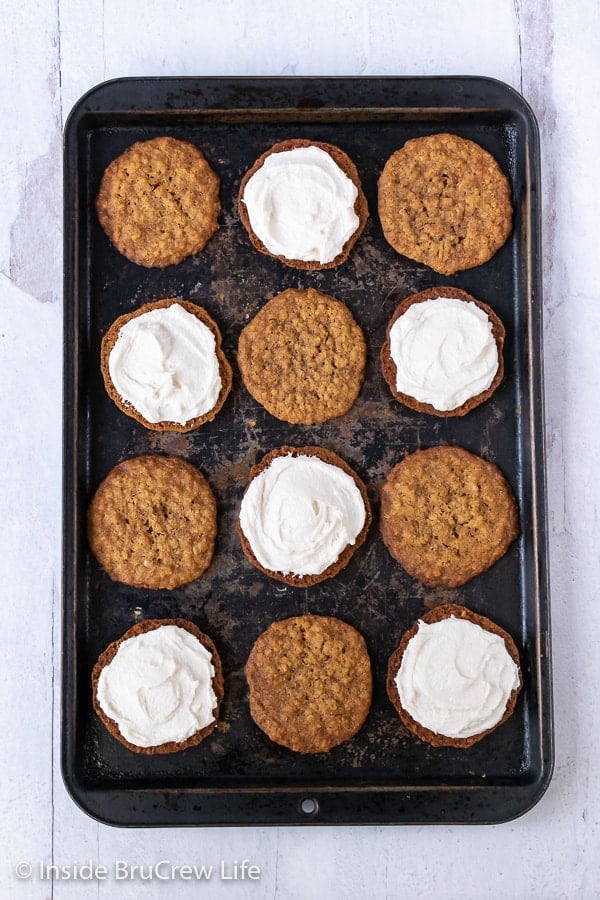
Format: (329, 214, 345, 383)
(62, 78, 553, 825)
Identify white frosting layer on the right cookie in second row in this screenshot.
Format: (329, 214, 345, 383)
(390, 297, 498, 412)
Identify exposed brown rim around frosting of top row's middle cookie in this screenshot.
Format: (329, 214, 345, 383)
(238, 138, 369, 269)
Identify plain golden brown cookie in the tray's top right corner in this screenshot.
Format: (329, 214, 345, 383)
(378, 134, 512, 275)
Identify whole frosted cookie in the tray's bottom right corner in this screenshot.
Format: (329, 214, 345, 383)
(387, 604, 522, 748)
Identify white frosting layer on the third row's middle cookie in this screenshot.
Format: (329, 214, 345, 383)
(240, 455, 366, 576)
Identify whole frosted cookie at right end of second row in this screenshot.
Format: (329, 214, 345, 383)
(381, 287, 505, 417)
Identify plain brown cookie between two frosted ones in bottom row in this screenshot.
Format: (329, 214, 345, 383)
(245, 615, 373, 753)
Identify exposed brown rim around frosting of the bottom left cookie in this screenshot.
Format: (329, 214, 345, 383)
(92, 619, 224, 755)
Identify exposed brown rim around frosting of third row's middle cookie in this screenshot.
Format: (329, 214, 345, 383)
(236, 445, 372, 588)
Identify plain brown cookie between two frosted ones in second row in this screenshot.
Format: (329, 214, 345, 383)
(238, 288, 367, 425)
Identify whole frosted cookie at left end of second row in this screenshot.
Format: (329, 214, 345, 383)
(101, 298, 232, 432)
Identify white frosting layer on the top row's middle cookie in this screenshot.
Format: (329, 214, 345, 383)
(242, 146, 360, 264)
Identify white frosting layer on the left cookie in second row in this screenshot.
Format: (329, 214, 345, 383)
(108, 303, 221, 425)
